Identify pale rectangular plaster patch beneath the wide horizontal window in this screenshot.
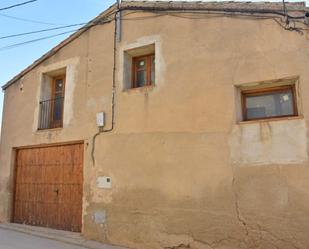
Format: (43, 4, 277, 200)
(229, 119, 308, 165)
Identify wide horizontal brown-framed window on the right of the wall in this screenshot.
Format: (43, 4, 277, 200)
(241, 85, 297, 120)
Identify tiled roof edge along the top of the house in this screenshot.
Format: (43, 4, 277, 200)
(2, 0, 309, 90)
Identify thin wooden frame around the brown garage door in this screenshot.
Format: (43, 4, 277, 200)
(9, 140, 85, 232)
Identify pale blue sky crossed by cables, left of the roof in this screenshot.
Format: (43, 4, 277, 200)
(0, 0, 115, 124)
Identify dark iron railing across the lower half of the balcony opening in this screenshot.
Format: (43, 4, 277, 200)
(39, 97, 64, 130)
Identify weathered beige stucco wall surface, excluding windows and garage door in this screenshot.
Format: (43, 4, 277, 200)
(0, 9, 309, 249)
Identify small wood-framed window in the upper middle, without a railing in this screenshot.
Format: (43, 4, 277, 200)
(132, 54, 155, 88)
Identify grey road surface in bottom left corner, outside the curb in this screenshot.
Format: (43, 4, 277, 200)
(0, 228, 92, 249)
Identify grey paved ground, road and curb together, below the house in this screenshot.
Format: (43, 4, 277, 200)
(0, 224, 128, 249)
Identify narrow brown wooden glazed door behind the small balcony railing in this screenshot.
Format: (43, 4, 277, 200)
(51, 75, 65, 128)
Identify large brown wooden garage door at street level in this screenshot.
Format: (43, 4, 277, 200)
(13, 144, 83, 232)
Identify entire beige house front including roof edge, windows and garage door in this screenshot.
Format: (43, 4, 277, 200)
(0, 1, 309, 249)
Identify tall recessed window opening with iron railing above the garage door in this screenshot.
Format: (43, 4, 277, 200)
(39, 75, 65, 130)
